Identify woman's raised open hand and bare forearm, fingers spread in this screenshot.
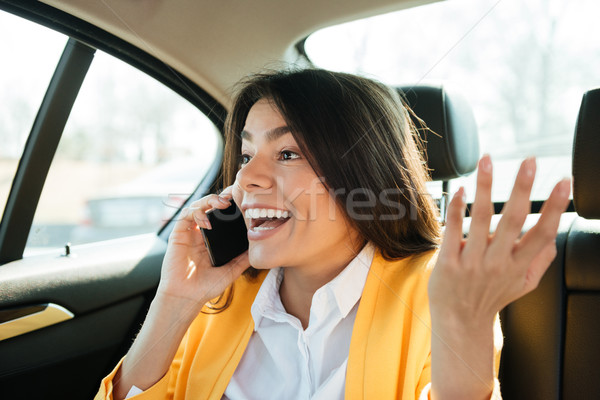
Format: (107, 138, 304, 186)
(429, 156, 570, 399)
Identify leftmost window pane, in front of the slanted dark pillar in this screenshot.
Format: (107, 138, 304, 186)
(0, 11, 67, 217)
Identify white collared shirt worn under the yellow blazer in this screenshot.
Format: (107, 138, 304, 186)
(223, 244, 374, 400)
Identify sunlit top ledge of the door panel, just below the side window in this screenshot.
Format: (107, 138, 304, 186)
(0, 234, 166, 315)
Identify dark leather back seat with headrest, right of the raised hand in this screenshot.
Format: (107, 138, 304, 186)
(500, 90, 600, 400)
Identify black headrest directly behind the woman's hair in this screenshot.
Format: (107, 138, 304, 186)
(398, 86, 479, 181)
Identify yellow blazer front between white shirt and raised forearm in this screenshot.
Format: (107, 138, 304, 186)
(345, 251, 434, 400)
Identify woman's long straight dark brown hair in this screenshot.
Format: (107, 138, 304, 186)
(223, 69, 440, 275)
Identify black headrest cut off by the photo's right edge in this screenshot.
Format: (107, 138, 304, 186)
(573, 89, 600, 219)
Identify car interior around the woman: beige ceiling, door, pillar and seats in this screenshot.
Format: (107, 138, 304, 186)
(0, 0, 600, 400)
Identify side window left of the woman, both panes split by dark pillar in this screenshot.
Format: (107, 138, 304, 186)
(0, 12, 222, 255)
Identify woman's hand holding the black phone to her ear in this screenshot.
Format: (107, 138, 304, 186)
(157, 187, 250, 315)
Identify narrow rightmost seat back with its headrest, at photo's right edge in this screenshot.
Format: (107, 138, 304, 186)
(563, 89, 600, 399)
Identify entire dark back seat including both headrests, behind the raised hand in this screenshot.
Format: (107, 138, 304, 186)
(399, 86, 600, 400)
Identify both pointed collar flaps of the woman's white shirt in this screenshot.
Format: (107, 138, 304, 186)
(250, 243, 375, 330)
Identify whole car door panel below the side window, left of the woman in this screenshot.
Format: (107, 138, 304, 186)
(0, 234, 166, 399)
